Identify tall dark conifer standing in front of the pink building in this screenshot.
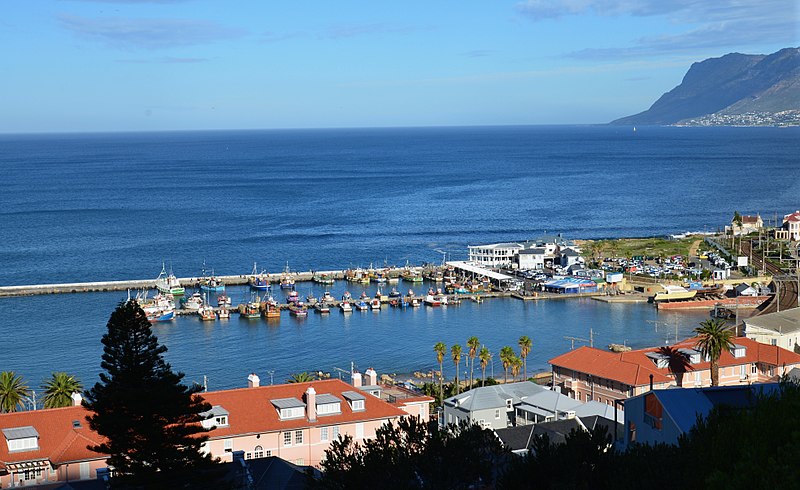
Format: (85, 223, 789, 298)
(84, 301, 218, 488)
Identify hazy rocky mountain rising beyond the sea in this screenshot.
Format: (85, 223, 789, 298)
(611, 48, 800, 125)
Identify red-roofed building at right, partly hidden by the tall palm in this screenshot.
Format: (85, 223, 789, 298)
(550, 337, 800, 405)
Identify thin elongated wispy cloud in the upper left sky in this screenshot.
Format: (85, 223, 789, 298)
(58, 14, 244, 49)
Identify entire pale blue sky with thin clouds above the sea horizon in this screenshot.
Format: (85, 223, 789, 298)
(0, 0, 800, 133)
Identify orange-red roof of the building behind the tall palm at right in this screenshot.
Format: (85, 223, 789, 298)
(549, 337, 800, 386)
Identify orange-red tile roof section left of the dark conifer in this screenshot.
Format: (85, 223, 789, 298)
(0, 407, 106, 467)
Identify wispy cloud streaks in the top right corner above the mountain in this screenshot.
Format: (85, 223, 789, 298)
(516, 0, 800, 59)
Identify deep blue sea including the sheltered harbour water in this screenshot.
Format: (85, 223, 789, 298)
(0, 126, 800, 389)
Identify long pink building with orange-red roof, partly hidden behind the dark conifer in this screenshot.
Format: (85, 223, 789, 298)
(0, 369, 433, 488)
